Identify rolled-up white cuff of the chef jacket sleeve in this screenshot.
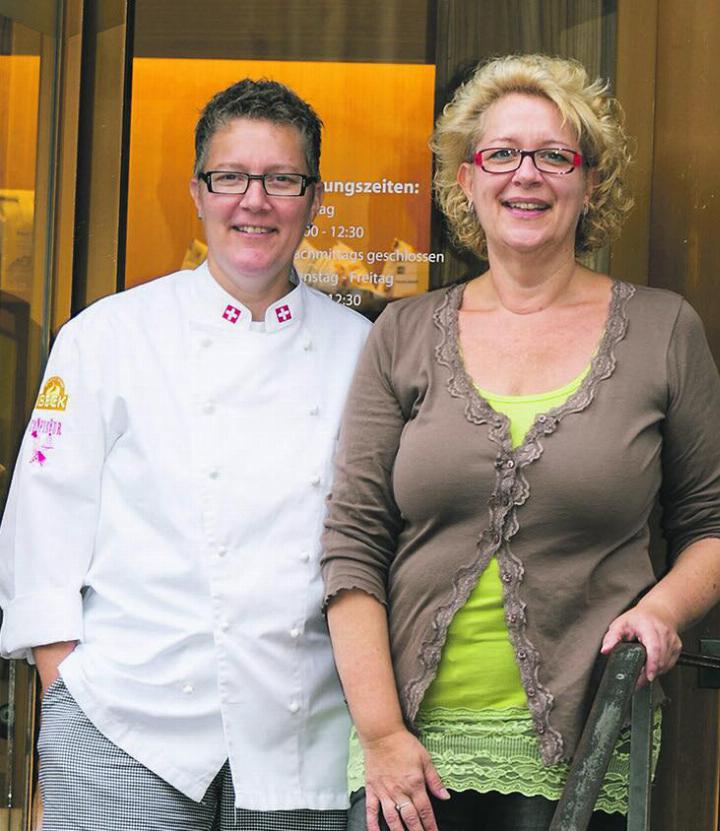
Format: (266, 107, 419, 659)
(0, 590, 83, 660)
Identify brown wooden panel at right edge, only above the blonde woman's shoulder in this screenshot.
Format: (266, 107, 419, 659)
(650, 0, 720, 360)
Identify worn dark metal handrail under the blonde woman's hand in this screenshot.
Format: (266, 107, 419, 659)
(549, 643, 720, 831)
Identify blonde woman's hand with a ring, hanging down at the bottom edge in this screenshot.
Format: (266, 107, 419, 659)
(362, 728, 450, 831)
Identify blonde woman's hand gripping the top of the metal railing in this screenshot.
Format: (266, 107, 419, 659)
(600, 598, 682, 687)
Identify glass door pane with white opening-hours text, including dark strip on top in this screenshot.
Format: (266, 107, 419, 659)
(124, 0, 444, 318)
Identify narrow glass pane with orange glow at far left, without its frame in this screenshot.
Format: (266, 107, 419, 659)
(0, 16, 47, 829)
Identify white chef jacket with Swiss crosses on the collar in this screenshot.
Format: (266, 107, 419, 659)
(0, 266, 369, 810)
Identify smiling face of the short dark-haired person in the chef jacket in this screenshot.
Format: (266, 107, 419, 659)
(190, 118, 322, 317)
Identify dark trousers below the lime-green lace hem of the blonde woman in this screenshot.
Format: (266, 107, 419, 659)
(347, 790, 626, 831)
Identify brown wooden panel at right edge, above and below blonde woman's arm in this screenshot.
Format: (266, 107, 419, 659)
(649, 0, 720, 831)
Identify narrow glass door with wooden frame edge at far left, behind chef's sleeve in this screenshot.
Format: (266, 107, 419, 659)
(0, 2, 58, 831)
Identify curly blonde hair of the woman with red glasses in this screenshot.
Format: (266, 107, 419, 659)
(430, 55, 633, 257)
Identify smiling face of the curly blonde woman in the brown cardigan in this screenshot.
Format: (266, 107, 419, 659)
(458, 93, 592, 258)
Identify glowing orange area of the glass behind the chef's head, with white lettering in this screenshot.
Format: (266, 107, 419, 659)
(125, 58, 436, 318)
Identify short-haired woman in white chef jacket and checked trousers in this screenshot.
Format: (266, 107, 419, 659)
(0, 79, 368, 831)
